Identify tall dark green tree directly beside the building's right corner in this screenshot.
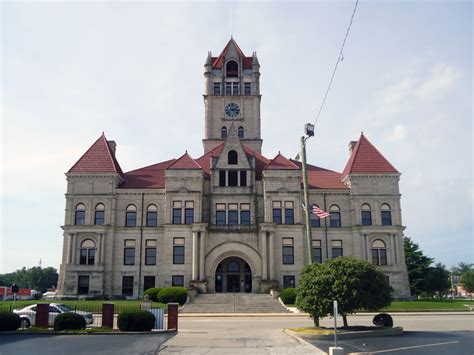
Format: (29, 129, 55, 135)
(403, 237, 433, 296)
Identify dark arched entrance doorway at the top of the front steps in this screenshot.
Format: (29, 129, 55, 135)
(215, 257, 252, 292)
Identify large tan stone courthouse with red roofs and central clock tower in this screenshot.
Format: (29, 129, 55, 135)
(59, 39, 410, 298)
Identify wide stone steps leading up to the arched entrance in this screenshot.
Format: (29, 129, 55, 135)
(181, 293, 290, 313)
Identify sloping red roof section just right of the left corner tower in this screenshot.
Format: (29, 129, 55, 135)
(120, 159, 176, 189)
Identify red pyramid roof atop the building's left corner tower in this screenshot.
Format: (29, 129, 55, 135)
(68, 133, 123, 177)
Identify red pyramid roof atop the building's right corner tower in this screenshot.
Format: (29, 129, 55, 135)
(342, 133, 398, 176)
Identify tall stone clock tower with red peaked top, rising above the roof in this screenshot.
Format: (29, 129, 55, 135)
(202, 38, 262, 153)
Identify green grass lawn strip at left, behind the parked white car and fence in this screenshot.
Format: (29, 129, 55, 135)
(0, 300, 166, 312)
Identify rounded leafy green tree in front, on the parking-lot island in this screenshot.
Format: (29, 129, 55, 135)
(296, 257, 391, 326)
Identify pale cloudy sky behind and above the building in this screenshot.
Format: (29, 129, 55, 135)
(0, 1, 474, 273)
